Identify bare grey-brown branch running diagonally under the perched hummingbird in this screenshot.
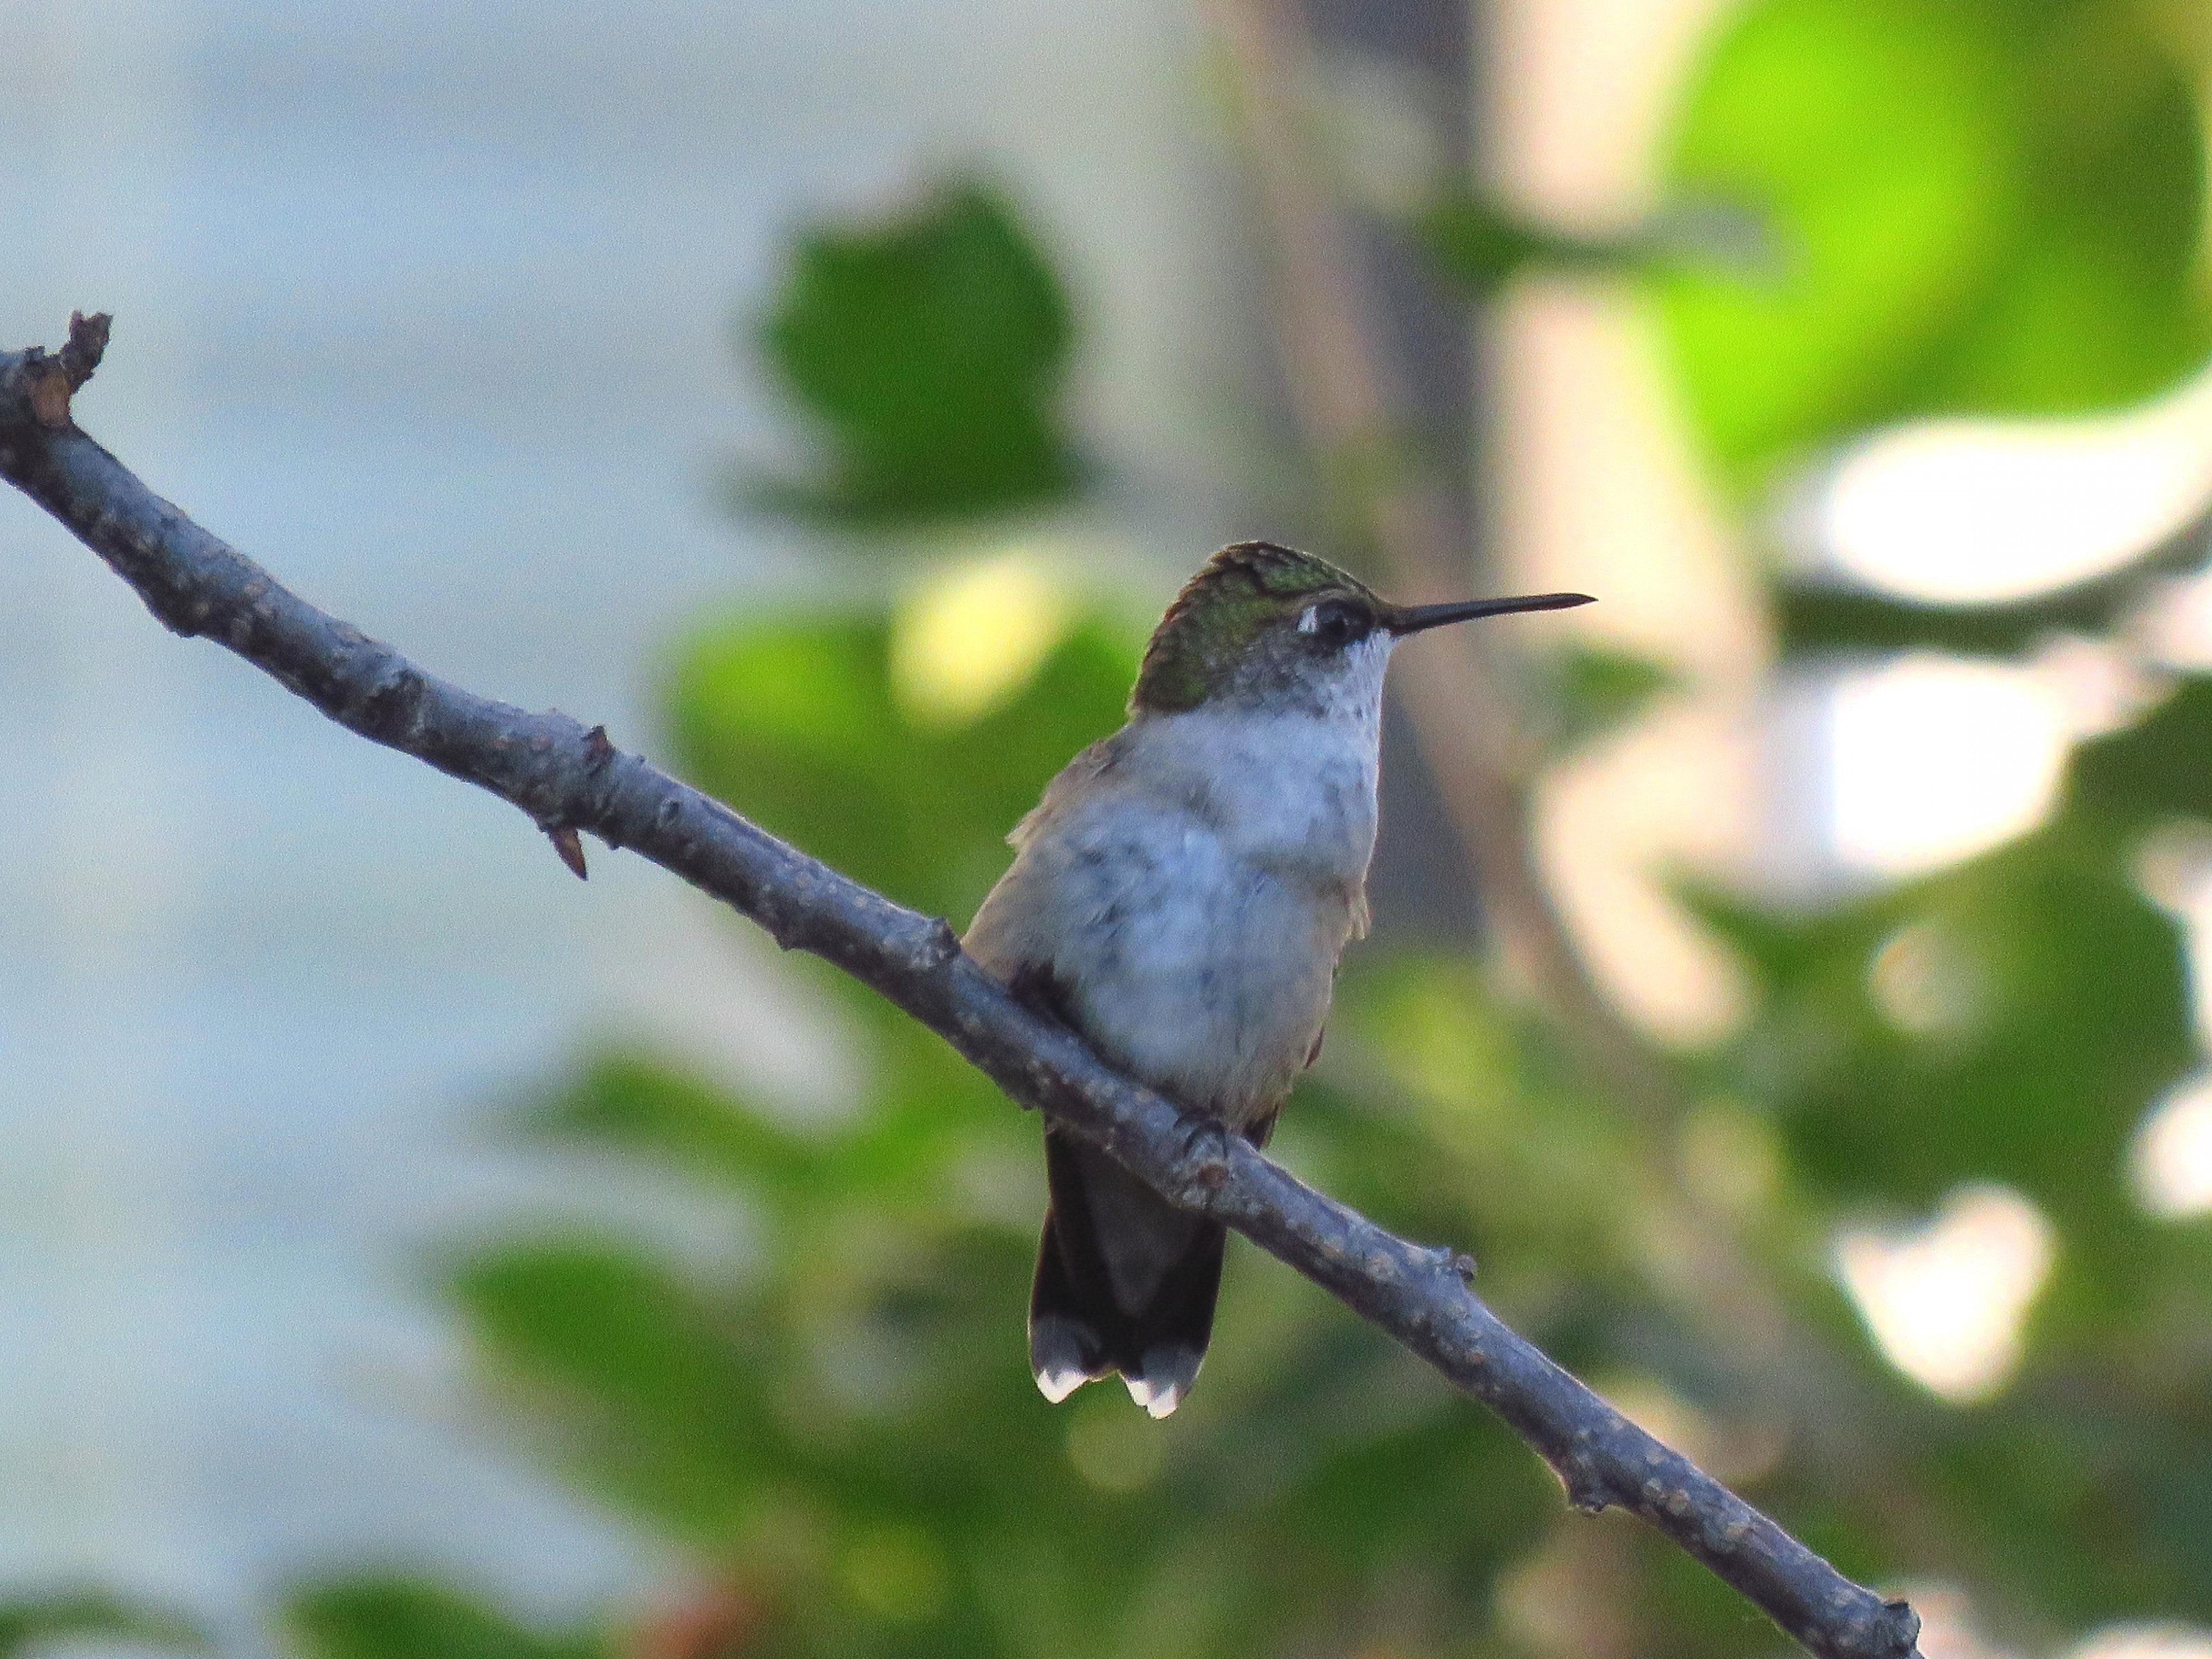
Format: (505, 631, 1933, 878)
(0, 317, 1920, 1659)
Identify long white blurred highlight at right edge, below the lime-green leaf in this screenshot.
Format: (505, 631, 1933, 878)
(1790, 376, 2212, 604)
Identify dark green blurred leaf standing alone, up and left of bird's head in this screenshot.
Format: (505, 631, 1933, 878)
(756, 184, 1080, 522)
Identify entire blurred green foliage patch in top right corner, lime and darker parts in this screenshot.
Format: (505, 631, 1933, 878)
(1663, 0, 2212, 482)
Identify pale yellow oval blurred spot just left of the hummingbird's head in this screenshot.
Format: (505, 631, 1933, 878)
(892, 549, 1071, 726)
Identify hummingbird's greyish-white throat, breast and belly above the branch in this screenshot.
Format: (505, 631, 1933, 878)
(966, 644, 1387, 1126)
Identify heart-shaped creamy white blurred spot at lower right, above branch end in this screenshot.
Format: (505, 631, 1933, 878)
(1836, 1185, 2057, 1405)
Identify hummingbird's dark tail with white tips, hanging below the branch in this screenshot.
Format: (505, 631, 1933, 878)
(1029, 1130, 1228, 1418)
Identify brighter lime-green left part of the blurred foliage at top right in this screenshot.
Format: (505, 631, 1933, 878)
(1666, 0, 2011, 480)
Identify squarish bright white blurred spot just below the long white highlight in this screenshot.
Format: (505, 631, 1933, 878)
(1827, 655, 2068, 876)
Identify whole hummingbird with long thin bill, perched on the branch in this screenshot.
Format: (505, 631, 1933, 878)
(962, 542, 1591, 1418)
